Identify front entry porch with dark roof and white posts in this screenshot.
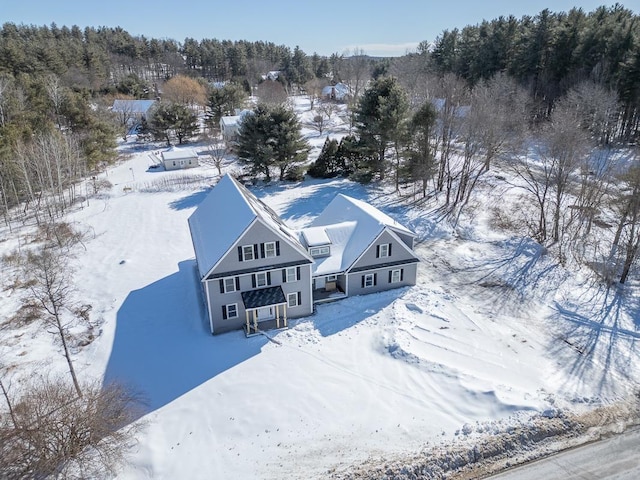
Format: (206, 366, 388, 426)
(242, 287, 287, 337)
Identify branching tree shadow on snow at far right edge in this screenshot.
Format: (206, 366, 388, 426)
(550, 284, 640, 395)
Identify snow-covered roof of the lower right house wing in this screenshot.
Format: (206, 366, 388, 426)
(301, 194, 415, 275)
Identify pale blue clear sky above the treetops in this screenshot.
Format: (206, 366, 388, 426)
(0, 0, 640, 56)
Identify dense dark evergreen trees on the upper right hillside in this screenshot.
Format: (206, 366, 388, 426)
(418, 4, 640, 141)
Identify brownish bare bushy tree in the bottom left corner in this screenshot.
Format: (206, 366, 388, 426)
(0, 379, 142, 480)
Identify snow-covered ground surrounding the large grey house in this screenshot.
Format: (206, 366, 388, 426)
(0, 98, 640, 479)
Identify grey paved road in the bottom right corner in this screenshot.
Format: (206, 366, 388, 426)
(490, 429, 640, 480)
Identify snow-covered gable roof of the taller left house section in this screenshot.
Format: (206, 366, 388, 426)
(189, 174, 308, 278)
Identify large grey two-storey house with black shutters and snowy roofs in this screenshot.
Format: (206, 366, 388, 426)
(189, 175, 419, 335)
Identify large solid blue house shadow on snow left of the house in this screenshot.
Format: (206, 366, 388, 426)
(103, 260, 268, 420)
